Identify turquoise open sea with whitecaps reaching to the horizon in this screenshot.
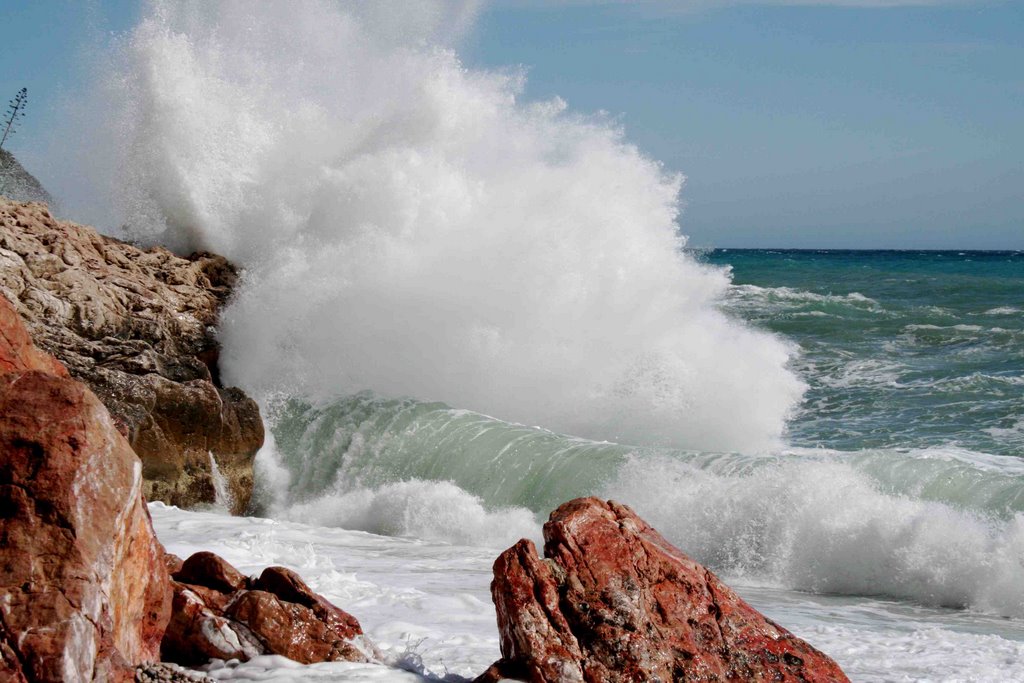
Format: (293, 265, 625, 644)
(705, 250, 1024, 458)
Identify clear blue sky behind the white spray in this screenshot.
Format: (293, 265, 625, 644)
(0, 0, 1024, 249)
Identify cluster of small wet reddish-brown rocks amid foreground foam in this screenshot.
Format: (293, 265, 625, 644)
(163, 552, 380, 666)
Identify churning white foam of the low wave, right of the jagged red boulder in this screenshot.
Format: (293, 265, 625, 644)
(603, 454, 1024, 617)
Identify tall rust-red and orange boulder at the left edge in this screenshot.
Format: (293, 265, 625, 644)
(0, 297, 171, 681)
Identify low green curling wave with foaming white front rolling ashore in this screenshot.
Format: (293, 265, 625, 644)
(257, 395, 1024, 617)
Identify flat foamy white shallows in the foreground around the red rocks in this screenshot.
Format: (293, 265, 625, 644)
(150, 503, 1024, 682)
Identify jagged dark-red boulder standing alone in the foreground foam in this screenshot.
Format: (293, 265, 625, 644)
(477, 498, 847, 683)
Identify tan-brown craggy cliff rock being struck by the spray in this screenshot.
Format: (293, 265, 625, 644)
(0, 199, 263, 513)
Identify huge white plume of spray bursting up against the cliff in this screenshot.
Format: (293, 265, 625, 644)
(75, 0, 804, 452)
